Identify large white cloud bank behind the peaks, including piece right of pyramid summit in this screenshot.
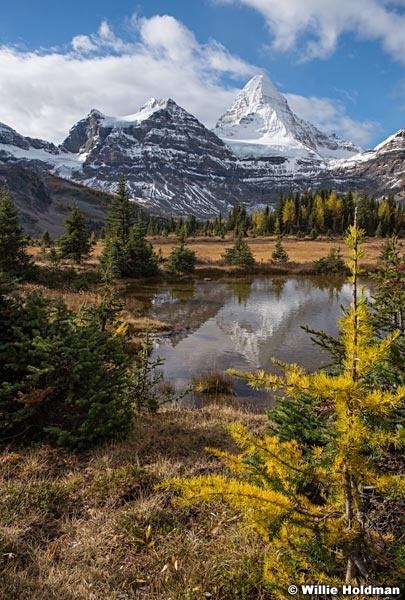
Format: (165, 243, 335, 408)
(0, 15, 375, 144)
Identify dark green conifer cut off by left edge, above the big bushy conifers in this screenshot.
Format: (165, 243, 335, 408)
(0, 192, 29, 275)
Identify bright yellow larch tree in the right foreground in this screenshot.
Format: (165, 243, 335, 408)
(164, 219, 405, 598)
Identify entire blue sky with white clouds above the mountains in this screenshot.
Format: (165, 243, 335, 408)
(0, 0, 405, 148)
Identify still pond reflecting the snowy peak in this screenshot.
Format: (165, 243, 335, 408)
(124, 277, 370, 406)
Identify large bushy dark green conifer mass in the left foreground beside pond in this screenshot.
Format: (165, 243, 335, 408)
(0, 279, 133, 450)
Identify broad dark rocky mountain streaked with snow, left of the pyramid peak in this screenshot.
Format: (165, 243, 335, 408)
(61, 99, 252, 217)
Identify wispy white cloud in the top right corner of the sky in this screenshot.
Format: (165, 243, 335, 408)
(213, 0, 405, 62)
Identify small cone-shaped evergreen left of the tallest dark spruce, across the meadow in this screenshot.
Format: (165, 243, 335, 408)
(58, 204, 90, 263)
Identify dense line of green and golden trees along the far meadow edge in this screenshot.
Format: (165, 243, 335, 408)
(147, 190, 405, 238)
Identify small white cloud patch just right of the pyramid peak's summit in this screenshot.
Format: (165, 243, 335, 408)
(285, 94, 381, 147)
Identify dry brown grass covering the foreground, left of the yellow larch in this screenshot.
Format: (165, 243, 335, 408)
(0, 407, 271, 600)
